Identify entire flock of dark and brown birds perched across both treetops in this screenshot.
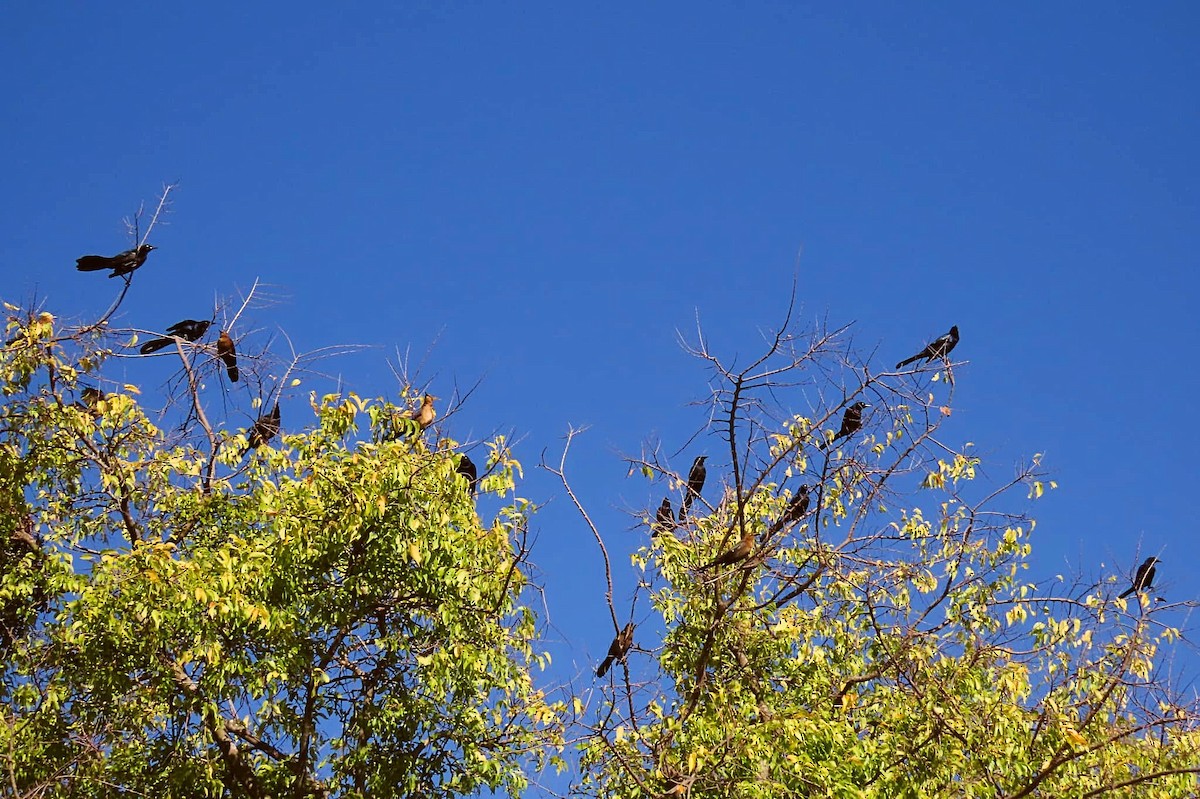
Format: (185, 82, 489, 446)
(68, 244, 1159, 677)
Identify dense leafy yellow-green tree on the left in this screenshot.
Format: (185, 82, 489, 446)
(0, 195, 562, 799)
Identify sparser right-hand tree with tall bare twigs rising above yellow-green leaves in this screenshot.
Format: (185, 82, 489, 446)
(564, 303, 1200, 799)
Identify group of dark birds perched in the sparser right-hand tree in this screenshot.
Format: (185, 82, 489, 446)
(596, 325, 1159, 677)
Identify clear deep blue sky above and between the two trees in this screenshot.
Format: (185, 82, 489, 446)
(0, 2, 1200, 782)
